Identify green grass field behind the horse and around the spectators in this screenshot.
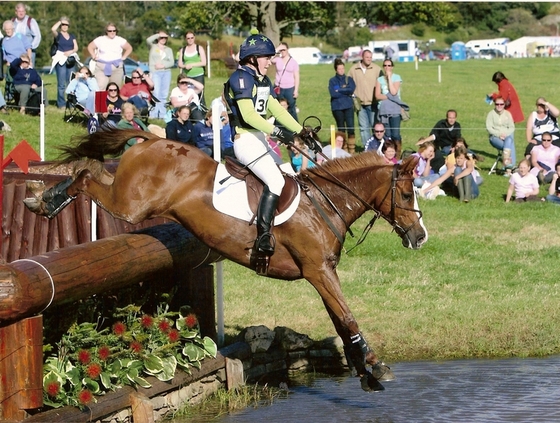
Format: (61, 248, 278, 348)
(0, 58, 560, 361)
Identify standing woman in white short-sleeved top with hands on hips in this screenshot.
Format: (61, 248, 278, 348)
(88, 22, 132, 90)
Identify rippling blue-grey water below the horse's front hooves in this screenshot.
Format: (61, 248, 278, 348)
(212, 356, 560, 423)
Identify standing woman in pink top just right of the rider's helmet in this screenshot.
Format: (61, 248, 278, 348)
(272, 43, 299, 120)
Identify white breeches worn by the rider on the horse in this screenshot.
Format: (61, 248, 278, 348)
(233, 132, 284, 195)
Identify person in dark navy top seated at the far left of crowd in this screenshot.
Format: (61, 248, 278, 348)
(10, 54, 43, 115)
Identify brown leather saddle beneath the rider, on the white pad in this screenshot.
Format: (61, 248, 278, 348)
(225, 156, 298, 216)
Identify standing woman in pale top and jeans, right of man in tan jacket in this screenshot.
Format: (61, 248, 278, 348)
(375, 59, 408, 154)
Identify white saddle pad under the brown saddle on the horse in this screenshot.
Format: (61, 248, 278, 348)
(212, 163, 301, 226)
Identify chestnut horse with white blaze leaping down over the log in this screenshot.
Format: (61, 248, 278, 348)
(26, 130, 428, 391)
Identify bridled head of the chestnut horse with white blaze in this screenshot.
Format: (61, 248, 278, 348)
(377, 157, 428, 249)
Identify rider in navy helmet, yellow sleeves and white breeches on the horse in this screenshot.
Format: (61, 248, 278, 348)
(224, 34, 303, 256)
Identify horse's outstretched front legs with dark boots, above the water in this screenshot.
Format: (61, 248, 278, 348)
(306, 269, 395, 391)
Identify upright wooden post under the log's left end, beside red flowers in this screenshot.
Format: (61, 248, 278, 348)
(0, 316, 43, 421)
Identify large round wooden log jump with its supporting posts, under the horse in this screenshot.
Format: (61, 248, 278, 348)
(0, 223, 221, 421)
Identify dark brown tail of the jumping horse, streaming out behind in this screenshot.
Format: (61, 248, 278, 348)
(58, 128, 160, 163)
